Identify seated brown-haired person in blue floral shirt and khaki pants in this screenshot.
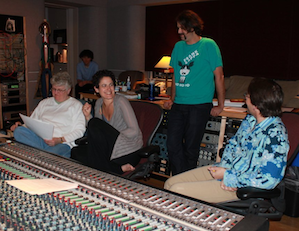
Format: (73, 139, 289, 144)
(164, 78, 289, 203)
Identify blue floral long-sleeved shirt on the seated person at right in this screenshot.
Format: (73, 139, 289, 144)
(215, 115, 289, 189)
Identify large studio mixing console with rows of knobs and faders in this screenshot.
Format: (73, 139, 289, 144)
(0, 142, 268, 231)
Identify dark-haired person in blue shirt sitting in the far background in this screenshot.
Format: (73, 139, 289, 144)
(75, 50, 99, 99)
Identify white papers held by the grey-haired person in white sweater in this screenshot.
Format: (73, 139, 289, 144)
(20, 113, 54, 140)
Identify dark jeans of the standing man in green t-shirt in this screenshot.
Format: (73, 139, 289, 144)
(167, 103, 212, 175)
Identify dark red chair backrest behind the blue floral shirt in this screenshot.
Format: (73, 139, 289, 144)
(281, 112, 299, 166)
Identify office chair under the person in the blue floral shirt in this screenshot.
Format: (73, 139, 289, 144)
(218, 112, 299, 220)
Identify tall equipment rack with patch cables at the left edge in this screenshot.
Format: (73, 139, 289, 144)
(0, 14, 27, 129)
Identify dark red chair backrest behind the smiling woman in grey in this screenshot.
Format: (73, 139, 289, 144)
(130, 100, 163, 147)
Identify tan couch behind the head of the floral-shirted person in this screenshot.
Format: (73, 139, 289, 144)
(224, 75, 299, 108)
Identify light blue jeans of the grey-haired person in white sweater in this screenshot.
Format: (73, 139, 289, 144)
(14, 126, 71, 157)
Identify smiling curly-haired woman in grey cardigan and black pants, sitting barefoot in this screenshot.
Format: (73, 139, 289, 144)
(72, 70, 143, 174)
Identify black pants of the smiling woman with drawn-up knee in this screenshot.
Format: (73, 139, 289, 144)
(72, 118, 140, 174)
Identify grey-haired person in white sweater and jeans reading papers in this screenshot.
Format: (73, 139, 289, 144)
(11, 72, 86, 157)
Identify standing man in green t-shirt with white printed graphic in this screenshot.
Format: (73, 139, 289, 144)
(164, 10, 225, 175)
